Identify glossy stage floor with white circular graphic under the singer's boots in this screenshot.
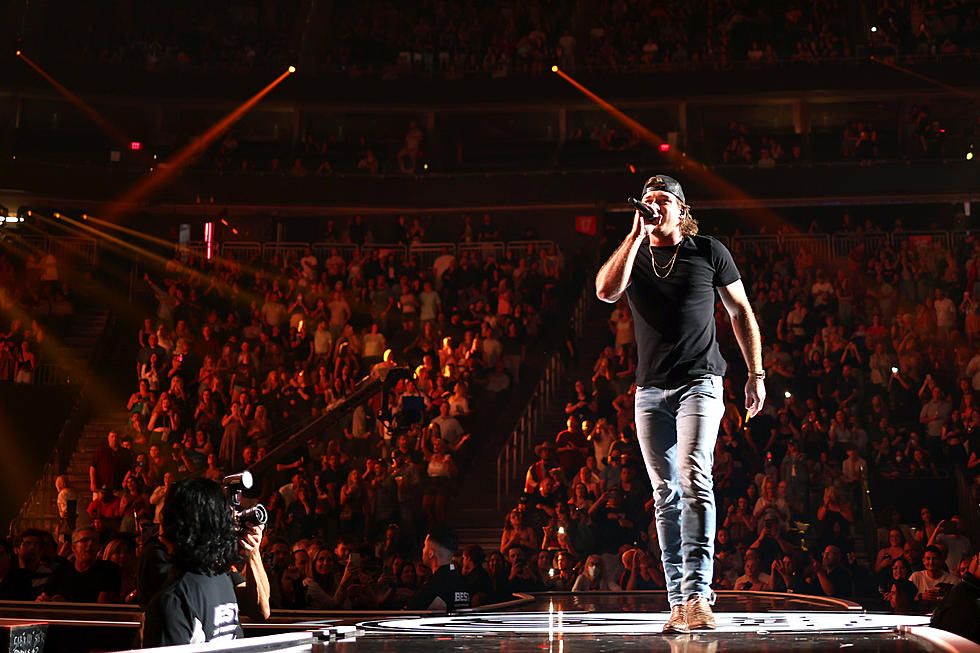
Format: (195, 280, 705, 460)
(329, 592, 962, 653)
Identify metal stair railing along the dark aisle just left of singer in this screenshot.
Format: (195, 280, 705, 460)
(496, 284, 595, 510)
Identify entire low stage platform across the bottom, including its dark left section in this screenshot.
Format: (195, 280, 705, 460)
(0, 592, 980, 653)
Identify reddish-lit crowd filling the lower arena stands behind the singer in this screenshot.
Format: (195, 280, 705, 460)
(7, 213, 980, 609)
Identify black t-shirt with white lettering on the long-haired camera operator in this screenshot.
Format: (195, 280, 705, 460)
(143, 572, 243, 647)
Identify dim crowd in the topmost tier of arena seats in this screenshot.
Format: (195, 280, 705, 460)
(30, 0, 978, 79)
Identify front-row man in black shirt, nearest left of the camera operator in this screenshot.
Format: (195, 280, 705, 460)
(37, 528, 122, 603)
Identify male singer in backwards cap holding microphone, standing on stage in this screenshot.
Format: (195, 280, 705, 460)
(596, 175, 766, 633)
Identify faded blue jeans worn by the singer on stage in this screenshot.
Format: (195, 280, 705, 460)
(636, 375, 725, 606)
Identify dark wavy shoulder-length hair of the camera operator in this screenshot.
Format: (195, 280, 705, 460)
(161, 478, 238, 576)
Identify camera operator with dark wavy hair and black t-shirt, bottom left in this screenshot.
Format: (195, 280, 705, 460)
(141, 478, 269, 647)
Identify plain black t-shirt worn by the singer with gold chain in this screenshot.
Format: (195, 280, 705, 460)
(626, 236, 741, 387)
